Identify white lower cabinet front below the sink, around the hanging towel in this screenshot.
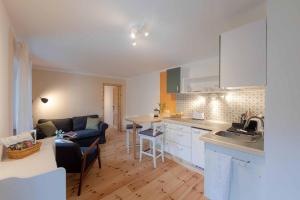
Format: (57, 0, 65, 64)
(204, 144, 264, 200)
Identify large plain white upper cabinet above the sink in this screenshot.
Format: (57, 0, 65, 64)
(220, 20, 267, 88)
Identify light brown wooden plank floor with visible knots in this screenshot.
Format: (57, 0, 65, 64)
(67, 130, 205, 200)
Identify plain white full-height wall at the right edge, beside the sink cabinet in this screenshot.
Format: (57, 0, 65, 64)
(265, 0, 300, 200)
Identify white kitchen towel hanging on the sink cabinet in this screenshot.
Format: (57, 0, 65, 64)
(204, 150, 232, 200)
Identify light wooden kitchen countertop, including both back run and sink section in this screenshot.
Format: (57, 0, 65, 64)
(163, 118, 264, 156)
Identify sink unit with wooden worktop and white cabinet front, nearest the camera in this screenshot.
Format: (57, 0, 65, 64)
(201, 128, 264, 200)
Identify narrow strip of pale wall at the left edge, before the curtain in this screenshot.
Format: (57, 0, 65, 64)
(0, 1, 12, 137)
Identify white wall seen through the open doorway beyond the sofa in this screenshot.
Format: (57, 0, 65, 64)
(104, 86, 114, 126)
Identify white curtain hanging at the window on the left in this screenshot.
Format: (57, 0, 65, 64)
(13, 42, 33, 134)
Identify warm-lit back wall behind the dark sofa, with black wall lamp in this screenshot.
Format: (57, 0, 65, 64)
(32, 69, 125, 123)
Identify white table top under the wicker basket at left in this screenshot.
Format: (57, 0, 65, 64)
(0, 137, 57, 180)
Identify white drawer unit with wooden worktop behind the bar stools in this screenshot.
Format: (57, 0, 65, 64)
(163, 118, 230, 169)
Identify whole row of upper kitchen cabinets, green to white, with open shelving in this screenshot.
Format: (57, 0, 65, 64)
(167, 19, 267, 93)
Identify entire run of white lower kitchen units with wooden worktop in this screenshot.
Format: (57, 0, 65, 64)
(163, 118, 264, 200)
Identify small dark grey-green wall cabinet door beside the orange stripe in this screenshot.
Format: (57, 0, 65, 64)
(167, 67, 181, 93)
